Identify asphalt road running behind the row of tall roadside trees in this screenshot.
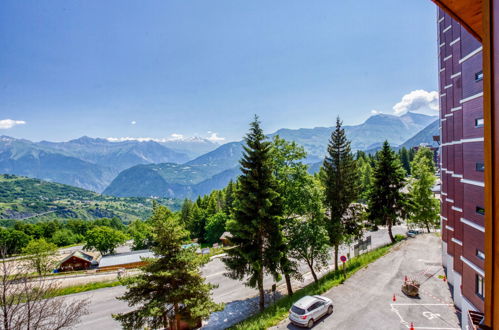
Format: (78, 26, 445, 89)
(68, 226, 406, 330)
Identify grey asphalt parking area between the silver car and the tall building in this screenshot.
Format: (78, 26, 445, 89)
(272, 234, 460, 330)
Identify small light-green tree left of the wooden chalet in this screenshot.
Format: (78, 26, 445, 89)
(23, 238, 57, 276)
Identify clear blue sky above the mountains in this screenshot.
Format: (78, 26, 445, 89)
(0, 0, 437, 141)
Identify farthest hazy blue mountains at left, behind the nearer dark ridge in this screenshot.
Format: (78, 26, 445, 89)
(0, 136, 218, 192)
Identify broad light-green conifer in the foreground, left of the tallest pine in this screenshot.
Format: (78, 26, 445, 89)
(113, 206, 221, 329)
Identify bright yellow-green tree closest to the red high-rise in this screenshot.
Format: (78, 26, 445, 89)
(409, 148, 440, 232)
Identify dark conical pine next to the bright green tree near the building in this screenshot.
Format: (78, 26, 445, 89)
(368, 141, 407, 243)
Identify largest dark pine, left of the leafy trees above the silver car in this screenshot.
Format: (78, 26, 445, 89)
(224, 116, 284, 310)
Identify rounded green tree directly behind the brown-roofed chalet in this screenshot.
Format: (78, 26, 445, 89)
(83, 226, 128, 255)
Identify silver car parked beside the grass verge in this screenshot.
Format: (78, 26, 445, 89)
(289, 296, 333, 328)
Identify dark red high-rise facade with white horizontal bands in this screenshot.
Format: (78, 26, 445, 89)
(438, 9, 485, 329)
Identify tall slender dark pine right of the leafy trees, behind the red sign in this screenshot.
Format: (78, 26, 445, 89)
(323, 117, 359, 269)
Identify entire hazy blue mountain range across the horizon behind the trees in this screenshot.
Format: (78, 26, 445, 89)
(0, 112, 438, 198)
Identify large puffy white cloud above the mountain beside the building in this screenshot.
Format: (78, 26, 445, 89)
(393, 89, 438, 115)
